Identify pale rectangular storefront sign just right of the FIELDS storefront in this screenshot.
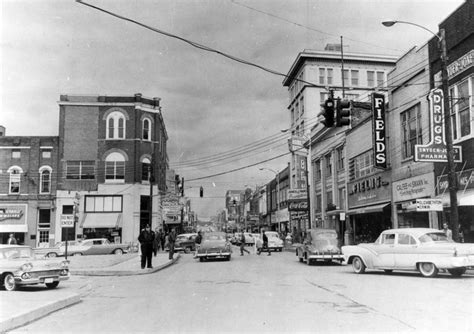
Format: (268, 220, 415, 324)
(392, 173, 434, 202)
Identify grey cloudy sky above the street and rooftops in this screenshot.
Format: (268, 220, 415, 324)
(0, 0, 463, 217)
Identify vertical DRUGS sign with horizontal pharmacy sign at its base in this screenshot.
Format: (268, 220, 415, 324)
(415, 88, 462, 162)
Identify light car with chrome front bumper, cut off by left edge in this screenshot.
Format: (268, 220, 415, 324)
(0, 245, 70, 291)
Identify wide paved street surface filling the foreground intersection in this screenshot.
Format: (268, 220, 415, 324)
(8, 247, 474, 333)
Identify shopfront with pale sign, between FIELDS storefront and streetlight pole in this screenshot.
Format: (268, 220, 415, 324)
(392, 172, 443, 228)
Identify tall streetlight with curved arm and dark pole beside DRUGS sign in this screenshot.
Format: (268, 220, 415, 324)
(382, 21, 459, 241)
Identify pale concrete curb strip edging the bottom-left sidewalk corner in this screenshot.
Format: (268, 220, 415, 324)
(0, 294, 81, 333)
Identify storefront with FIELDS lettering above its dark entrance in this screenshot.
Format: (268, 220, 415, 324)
(345, 172, 392, 244)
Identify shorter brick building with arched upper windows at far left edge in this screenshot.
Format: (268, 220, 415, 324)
(0, 134, 59, 247)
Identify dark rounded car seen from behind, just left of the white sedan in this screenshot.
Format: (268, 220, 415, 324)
(296, 228, 344, 265)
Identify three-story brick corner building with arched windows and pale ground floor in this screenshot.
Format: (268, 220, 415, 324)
(55, 94, 168, 242)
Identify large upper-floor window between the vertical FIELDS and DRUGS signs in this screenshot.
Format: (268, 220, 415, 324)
(400, 104, 423, 159)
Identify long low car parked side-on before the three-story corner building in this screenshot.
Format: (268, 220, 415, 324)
(68, 238, 130, 256)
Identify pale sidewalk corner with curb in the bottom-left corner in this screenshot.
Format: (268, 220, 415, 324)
(0, 288, 81, 333)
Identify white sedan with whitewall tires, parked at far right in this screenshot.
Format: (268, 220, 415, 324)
(342, 228, 474, 277)
